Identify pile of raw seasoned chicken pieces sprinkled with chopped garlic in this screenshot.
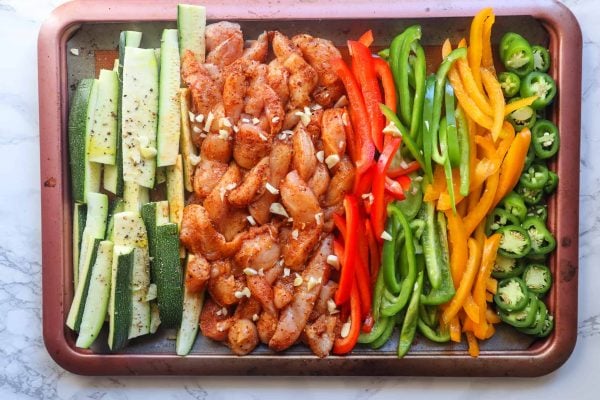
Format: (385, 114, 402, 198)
(180, 22, 354, 357)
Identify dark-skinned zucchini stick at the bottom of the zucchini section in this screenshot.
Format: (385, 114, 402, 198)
(108, 245, 134, 351)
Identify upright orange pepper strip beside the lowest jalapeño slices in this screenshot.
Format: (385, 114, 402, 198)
(473, 233, 500, 339)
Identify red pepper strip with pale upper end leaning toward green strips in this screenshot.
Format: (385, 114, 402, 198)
(371, 138, 402, 242)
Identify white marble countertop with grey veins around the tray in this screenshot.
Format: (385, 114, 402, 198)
(0, 0, 600, 400)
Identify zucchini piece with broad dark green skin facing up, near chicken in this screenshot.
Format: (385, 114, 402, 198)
(142, 201, 183, 328)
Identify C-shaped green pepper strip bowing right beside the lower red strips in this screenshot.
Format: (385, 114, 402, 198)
(381, 203, 417, 317)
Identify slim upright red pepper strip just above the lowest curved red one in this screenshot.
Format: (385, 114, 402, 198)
(334, 195, 360, 306)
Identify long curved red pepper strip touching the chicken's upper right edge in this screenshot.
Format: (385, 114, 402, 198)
(331, 58, 375, 176)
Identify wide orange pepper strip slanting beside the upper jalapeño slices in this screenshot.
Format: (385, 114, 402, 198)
(493, 128, 531, 206)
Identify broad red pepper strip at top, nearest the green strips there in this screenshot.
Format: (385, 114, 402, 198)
(348, 40, 384, 152)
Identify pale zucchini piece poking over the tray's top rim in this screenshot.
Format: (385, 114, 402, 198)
(177, 4, 206, 63)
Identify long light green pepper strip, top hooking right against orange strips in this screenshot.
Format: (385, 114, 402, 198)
(430, 47, 467, 165)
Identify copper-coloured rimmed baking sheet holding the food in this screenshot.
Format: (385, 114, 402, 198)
(38, 0, 582, 376)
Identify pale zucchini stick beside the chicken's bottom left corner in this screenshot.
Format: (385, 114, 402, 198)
(175, 254, 204, 356)
